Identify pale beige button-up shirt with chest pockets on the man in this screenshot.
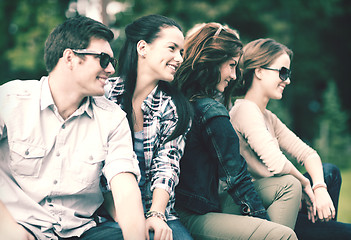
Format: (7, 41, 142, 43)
(0, 77, 140, 239)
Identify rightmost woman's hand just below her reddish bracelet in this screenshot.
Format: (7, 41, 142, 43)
(314, 187, 335, 222)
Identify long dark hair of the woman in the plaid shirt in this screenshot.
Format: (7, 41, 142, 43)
(117, 15, 192, 141)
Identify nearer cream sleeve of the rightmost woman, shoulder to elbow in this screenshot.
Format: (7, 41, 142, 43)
(230, 101, 292, 174)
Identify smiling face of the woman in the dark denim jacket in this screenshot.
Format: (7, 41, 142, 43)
(217, 57, 240, 92)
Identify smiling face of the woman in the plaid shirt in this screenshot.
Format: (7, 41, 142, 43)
(143, 27, 184, 82)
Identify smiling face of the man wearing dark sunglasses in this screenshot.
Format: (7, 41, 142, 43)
(72, 38, 115, 96)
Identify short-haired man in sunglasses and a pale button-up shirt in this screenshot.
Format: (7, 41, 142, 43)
(0, 17, 145, 240)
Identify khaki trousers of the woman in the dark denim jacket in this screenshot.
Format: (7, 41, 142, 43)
(176, 175, 301, 240)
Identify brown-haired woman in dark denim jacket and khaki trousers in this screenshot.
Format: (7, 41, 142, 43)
(173, 23, 301, 239)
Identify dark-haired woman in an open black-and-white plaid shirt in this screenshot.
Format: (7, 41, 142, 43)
(103, 15, 192, 240)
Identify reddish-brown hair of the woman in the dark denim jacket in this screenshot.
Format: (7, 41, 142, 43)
(173, 23, 243, 108)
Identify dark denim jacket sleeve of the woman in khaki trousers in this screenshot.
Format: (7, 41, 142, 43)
(203, 116, 266, 218)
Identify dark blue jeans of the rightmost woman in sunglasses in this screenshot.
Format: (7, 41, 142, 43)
(295, 163, 351, 240)
